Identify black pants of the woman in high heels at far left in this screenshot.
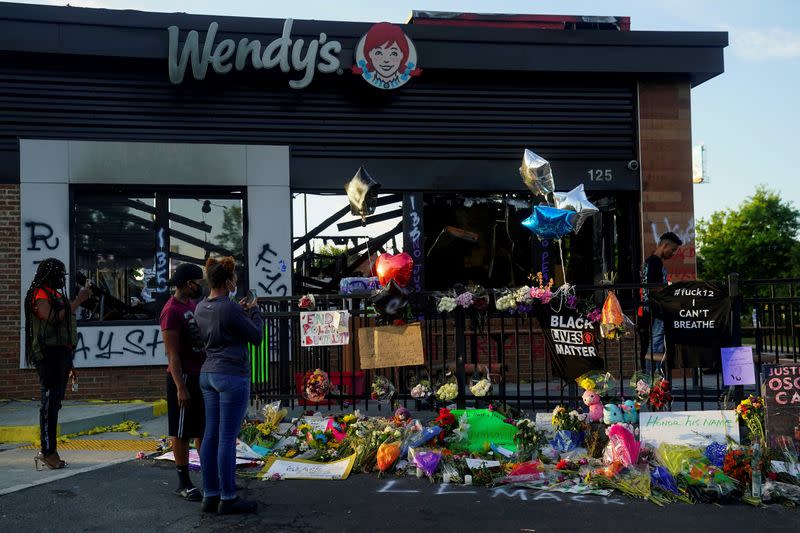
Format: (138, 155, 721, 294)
(36, 347, 72, 455)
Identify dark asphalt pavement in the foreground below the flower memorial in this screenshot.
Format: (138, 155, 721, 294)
(0, 460, 800, 533)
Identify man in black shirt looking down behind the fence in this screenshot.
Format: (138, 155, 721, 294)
(639, 231, 683, 372)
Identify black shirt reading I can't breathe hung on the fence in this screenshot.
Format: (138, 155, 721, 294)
(650, 281, 731, 346)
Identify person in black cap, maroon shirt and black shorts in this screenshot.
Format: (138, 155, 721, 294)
(160, 263, 205, 502)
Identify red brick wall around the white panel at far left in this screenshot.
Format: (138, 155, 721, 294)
(0, 184, 166, 400)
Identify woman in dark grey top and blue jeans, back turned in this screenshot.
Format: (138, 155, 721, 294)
(195, 257, 264, 514)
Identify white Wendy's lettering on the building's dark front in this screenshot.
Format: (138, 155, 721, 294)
(167, 19, 342, 89)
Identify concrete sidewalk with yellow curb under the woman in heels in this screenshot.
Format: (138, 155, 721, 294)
(0, 400, 167, 497)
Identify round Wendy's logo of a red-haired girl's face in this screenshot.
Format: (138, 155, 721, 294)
(352, 22, 422, 89)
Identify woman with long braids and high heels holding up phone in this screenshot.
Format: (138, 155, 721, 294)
(25, 258, 92, 470)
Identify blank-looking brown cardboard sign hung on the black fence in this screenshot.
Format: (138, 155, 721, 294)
(358, 322, 425, 370)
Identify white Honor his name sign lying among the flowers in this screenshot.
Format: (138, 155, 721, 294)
(639, 410, 739, 448)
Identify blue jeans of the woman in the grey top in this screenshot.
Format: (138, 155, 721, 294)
(200, 372, 250, 500)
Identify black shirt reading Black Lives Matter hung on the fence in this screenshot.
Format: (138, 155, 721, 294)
(537, 306, 603, 380)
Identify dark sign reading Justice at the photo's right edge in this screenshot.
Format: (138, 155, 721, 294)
(761, 365, 800, 449)
